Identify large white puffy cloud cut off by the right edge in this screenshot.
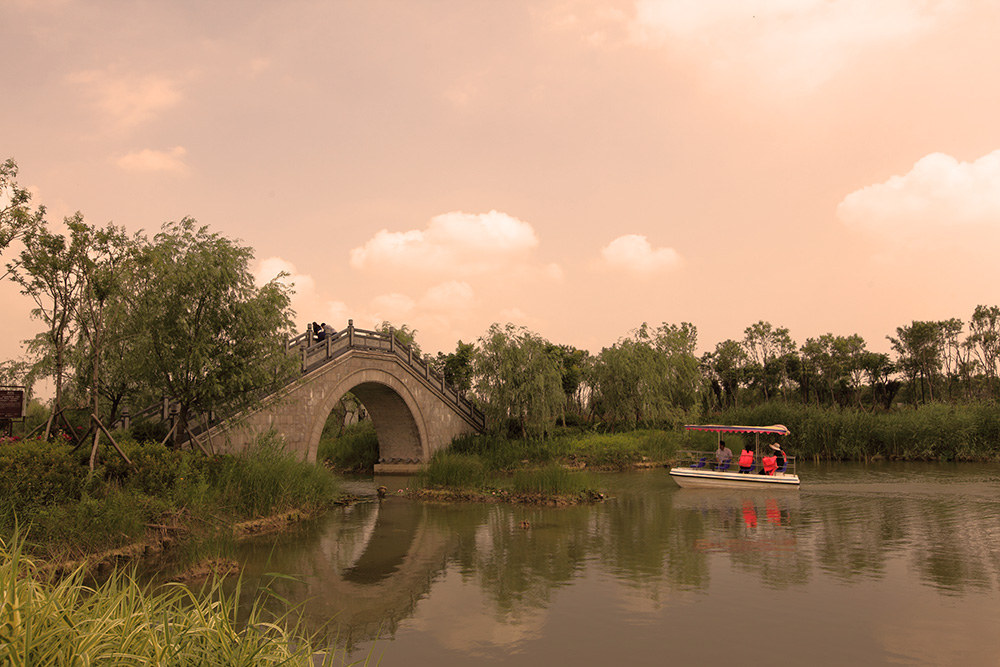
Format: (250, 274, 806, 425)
(837, 150, 1000, 235)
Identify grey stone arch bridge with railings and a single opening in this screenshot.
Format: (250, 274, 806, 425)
(199, 320, 486, 473)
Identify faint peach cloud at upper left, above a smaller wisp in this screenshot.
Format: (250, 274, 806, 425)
(69, 70, 182, 127)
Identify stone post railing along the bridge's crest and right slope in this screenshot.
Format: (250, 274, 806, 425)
(285, 320, 486, 429)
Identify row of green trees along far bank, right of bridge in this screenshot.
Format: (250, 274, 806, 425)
(452, 314, 1000, 444)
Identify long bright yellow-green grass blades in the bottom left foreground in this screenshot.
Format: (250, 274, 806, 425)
(0, 530, 367, 667)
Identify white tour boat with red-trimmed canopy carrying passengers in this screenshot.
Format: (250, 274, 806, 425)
(670, 424, 799, 489)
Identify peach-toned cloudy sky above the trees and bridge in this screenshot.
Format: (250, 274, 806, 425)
(0, 0, 1000, 370)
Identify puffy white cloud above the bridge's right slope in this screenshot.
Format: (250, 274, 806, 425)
(351, 210, 538, 275)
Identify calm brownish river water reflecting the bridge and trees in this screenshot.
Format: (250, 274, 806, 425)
(230, 463, 1000, 667)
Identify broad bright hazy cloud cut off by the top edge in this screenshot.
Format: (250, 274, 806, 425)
(560, 0, 960, 95)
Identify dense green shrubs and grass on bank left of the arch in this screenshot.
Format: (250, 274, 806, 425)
(0, 438, 338, 559)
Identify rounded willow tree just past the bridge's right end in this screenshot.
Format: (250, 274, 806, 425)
(473, 323, 565, 438)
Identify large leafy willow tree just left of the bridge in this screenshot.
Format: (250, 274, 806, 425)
(132, 218, 297, 448)
